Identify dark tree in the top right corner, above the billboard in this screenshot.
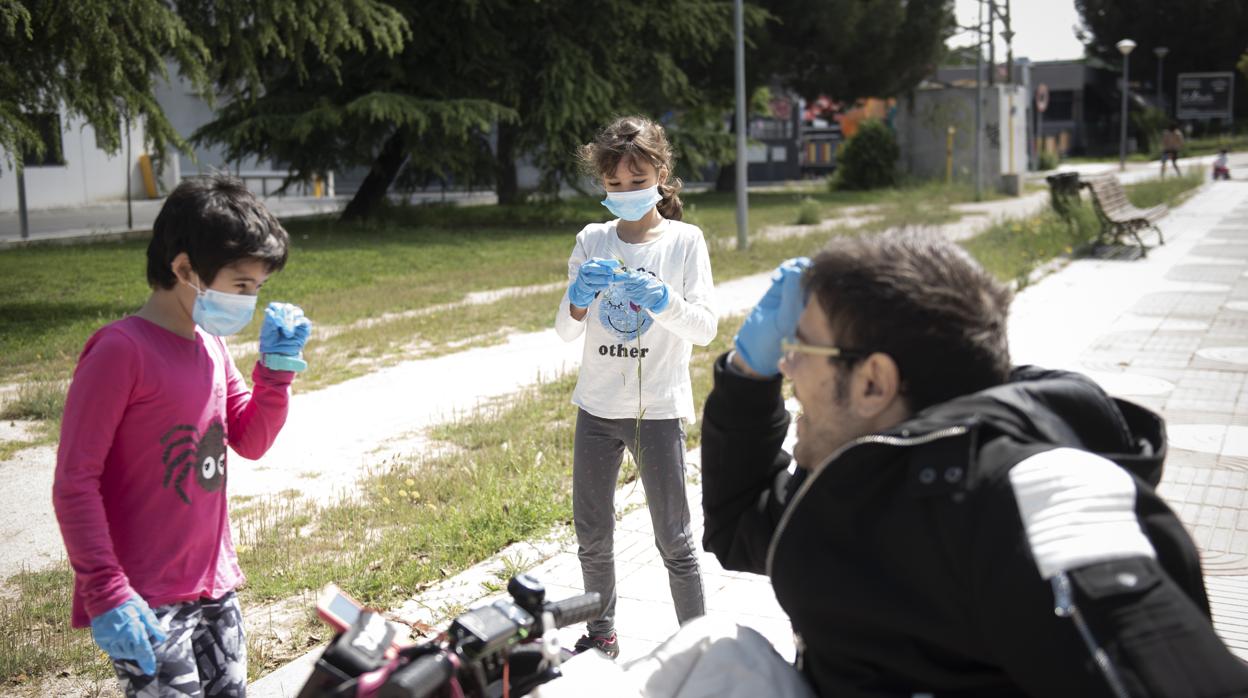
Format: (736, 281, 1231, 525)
(1075, 0, 1248, 114)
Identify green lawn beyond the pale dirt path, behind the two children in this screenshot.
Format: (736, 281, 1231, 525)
(0, 184, 993, 433)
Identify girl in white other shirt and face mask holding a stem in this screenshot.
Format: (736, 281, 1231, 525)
(555, 116, 718, 658)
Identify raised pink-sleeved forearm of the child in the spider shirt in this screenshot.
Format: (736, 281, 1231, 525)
(221, 345, 295, 461)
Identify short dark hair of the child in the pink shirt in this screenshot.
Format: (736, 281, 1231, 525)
(147, 175, 290, 288)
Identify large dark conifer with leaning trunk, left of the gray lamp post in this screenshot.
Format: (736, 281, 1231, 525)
(196, 0, 731, 219)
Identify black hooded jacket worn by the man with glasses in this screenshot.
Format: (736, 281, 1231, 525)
(703, 356, 1248, 698)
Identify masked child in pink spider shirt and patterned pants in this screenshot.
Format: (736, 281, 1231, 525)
(52, 177, 311, 697)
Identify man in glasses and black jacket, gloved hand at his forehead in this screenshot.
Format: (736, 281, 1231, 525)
(703, 233, 1248, 698)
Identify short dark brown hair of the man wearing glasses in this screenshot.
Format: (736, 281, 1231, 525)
(804, 231, 1011, 412)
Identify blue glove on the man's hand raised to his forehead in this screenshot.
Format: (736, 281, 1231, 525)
(733, 257, 810, 376)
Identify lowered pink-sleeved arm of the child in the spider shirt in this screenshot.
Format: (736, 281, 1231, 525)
(52, 332, 141, 618)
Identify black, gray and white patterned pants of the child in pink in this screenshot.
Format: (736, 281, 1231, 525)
(112, 592, 247, 698)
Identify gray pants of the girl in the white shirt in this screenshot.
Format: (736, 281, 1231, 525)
(572, 410, 706, 636)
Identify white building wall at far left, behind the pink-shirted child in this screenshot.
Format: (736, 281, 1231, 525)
(0, 112, 146, 211)
